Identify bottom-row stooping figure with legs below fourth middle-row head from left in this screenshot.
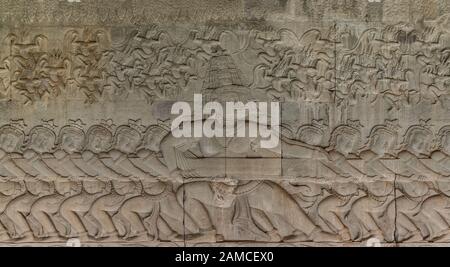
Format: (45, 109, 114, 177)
(84, 181, 142, 240)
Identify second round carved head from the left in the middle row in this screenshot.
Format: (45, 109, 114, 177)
(28, 126, 56, 153)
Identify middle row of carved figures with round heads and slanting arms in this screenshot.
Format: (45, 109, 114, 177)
(0, 121, 450, 181)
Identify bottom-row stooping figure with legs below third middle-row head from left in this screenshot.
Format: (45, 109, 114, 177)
(59, 180, 112, 240)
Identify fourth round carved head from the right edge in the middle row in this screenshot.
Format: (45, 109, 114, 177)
(329, 125, 361, 156)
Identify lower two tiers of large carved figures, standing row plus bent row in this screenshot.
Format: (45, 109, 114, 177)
(0, 120, 450, 243)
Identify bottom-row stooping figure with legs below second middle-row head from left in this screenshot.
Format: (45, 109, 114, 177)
(27, 180, 82, 240)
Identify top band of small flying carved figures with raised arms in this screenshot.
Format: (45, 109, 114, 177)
(0, 17, 450, 108)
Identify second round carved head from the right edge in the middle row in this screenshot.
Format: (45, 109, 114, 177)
(404, 126, 433, 155)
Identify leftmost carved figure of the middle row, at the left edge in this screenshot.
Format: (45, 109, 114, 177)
(0, 125, 29, 178)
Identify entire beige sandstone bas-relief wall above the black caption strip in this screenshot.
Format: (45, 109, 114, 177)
(0, 0, 450, 246)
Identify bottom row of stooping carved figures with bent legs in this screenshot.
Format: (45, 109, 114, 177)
(0, 179, 450, 243)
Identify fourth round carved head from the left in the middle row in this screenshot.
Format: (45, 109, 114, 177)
(86, 125, 113, 153)
